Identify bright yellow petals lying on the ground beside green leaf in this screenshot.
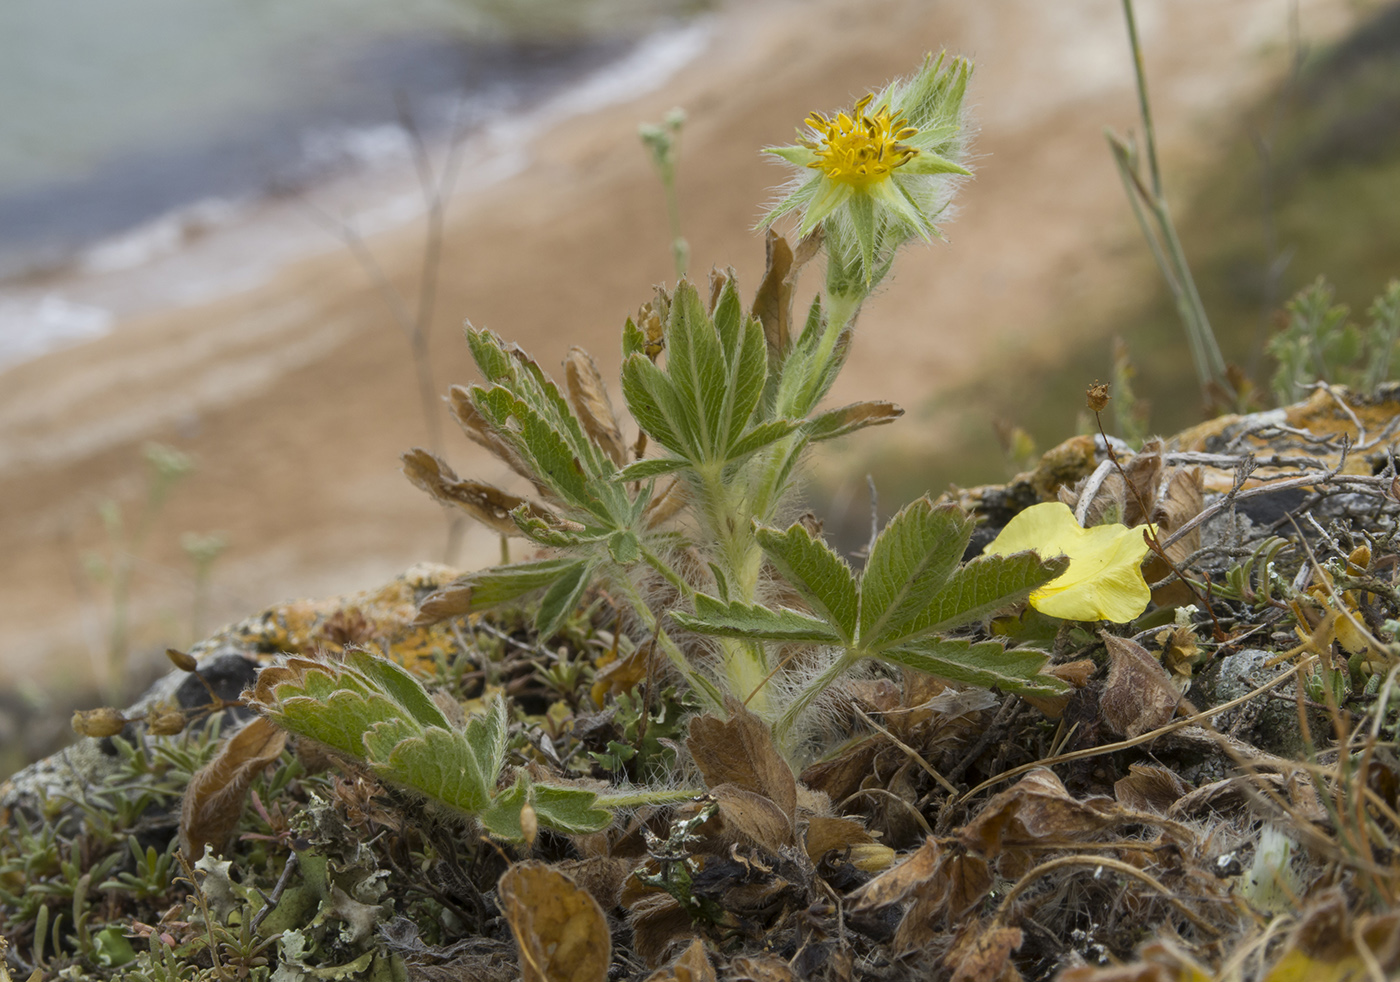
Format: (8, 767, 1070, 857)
(984, 502, 1152, 623)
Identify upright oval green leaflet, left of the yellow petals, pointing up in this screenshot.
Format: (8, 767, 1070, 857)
(860, 495, 972, 647)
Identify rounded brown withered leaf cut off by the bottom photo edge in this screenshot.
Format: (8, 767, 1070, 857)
(496, 860, 612, 982)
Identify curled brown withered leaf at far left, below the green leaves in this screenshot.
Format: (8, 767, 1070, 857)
(179, 716, 287, 862)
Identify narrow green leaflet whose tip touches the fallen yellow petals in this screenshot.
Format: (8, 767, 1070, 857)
(862, 552, 1070, 651)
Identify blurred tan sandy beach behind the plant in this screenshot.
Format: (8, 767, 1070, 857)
(0, 0, 1366, 700)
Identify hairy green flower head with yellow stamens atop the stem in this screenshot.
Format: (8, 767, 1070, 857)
(763, 55, 972, 293)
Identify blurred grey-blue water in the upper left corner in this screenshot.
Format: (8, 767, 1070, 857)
(0, 0, 700, 279)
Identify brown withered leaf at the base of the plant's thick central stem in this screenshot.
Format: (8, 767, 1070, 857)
(686, 699, 797, 824)
